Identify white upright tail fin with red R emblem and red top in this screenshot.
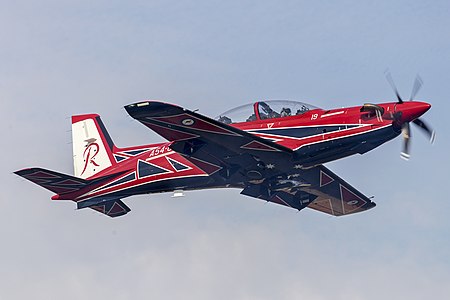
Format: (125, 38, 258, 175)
(72, 114, 116, 178)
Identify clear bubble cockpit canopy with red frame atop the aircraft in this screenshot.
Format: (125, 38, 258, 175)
(215, 100, 318, 124)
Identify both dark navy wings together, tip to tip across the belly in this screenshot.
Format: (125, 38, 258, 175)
(125, 101, 375, 216)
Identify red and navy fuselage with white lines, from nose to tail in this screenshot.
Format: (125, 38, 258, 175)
(57, 101, 429, 201)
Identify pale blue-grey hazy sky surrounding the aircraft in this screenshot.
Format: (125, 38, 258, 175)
(0, 0, 450, 300)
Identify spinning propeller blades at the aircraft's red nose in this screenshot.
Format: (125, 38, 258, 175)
(385, 70, 436, 160)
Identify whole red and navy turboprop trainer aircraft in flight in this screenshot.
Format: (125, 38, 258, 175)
(15, 85, 434, 217)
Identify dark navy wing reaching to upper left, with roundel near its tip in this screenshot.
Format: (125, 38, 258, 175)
(125, 101, 295, 182)
